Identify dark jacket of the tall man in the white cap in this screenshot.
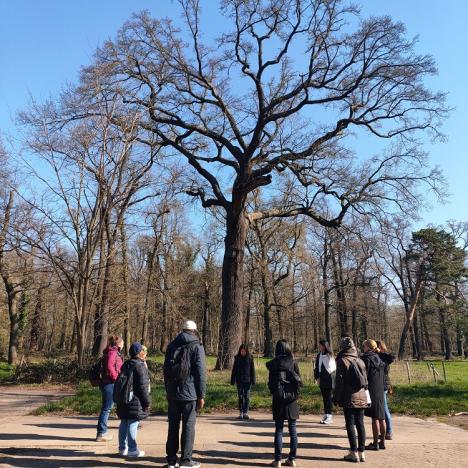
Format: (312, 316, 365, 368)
(164, 332, 206, 401)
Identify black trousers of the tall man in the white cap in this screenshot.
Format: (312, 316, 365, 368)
(166, 400, 197, 465)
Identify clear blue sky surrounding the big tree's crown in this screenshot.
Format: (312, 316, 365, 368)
(0, 0, 468, 224)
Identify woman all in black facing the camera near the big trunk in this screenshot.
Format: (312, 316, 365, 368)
(231, 344, 255, 419)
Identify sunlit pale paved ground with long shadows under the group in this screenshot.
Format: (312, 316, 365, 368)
(0, 413, 468, 468)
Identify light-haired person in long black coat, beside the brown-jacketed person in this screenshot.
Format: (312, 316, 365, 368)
(361, 340, 385, 450)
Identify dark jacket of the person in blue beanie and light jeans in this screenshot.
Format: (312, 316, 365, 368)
(117, 357, 150, 421)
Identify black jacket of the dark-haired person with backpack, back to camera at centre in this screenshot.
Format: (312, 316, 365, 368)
(266, 356, 302, 421)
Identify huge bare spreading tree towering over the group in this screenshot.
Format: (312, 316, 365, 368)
(28, 0, 447, 369)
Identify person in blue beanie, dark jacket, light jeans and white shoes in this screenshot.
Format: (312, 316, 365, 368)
(114, 343, 150, 458)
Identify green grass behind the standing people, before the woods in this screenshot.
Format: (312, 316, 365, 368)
(36, 356, 468, 416)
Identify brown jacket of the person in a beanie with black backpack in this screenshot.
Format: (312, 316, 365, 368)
(333, 347, 367, 408)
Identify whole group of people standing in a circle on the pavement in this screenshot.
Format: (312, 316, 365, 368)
(96, 321, 394, 468)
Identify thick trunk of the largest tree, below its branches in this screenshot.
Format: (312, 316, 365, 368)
(216, 203, 248, 370)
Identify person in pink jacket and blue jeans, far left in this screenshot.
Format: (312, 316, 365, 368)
(96, 335, 123, 442)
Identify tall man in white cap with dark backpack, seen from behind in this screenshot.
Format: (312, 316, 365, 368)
(164, 320, 206, 468)
